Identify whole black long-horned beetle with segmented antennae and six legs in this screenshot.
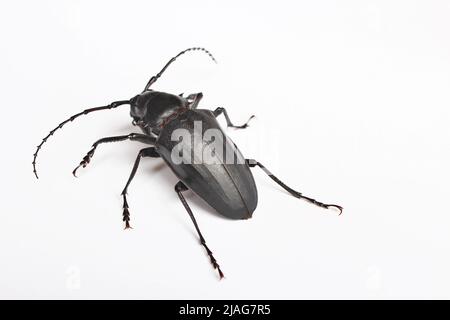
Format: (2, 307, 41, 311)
(32, 47, 343, 279)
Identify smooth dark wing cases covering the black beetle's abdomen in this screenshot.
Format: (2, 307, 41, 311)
(156, 110, 258, 219)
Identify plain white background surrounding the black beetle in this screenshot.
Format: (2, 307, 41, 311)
(0, 0, 450, 299)
